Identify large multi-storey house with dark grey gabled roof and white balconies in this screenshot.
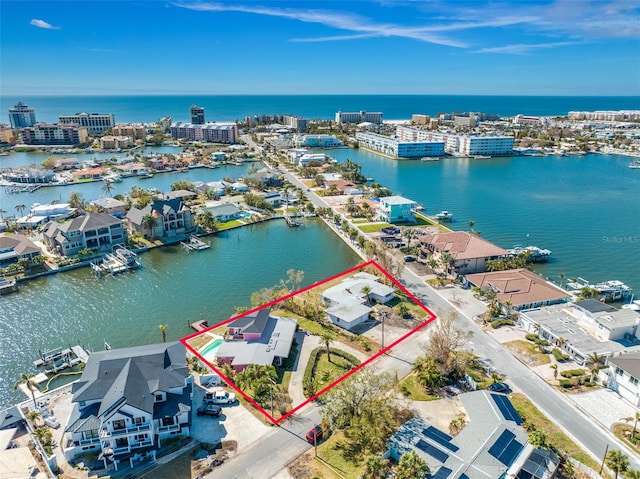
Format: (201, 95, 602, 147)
(61, 342, 192, 470)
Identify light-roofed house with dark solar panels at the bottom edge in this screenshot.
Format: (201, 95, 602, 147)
(383, 391, 560, 479)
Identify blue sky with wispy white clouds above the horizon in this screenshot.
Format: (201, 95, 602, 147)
(0, 0, 640, 95)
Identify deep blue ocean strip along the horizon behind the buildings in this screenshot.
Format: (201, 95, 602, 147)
(0, 95, 640, 123)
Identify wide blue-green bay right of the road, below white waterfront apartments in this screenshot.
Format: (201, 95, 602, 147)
(326, 149, 640, 297)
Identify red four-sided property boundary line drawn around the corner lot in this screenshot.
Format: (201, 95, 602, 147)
(180, 260, 436, 424)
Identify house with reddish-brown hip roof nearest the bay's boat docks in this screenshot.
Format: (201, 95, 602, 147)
(419, 231, 509, 274)
